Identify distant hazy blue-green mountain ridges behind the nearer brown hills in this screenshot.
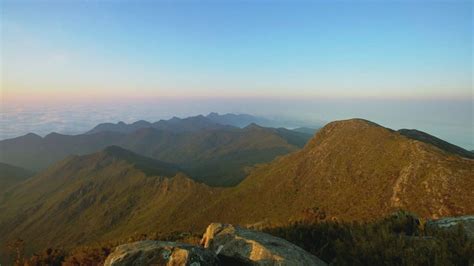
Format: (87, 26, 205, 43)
(0, 113, 311, 186)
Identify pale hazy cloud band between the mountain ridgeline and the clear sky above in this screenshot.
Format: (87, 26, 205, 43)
(0, 98, 474, 150)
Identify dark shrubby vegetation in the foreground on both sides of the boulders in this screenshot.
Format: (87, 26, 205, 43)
(5, 211, 474, 265)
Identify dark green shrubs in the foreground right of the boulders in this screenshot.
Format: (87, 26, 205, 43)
(264, 212, 474, 265)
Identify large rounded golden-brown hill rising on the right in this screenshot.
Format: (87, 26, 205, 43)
(196, 119, 474, 223)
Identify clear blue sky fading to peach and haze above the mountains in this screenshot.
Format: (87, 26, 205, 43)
(0, 0, 474, 149)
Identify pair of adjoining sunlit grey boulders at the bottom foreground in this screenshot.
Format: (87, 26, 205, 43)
(104, 223, 327, 266)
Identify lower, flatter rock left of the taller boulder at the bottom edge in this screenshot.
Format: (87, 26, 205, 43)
(104, 240, 218, 266)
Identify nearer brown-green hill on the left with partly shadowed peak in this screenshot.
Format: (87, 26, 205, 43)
(0, 147, 218, 254)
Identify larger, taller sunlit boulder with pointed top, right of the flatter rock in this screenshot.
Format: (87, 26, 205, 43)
(201, 223, 327, 265)
